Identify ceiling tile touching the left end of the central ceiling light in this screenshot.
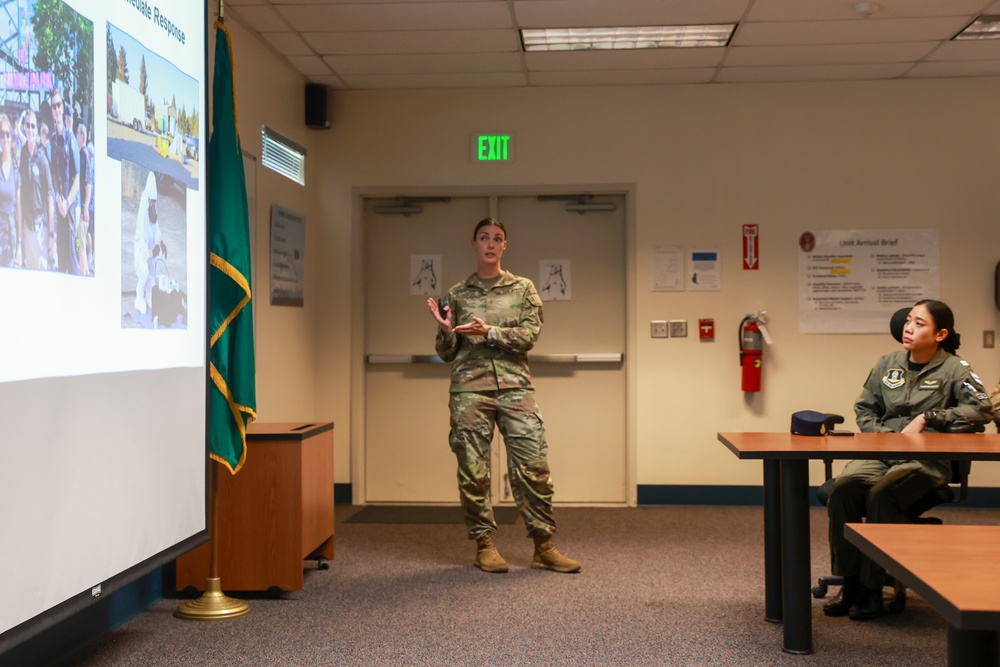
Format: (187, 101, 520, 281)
(302, 29, 521, 55)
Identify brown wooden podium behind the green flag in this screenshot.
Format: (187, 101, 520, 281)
(176, 422, 334, 591)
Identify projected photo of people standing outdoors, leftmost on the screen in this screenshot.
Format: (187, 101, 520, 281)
(0, 0, 96, 276)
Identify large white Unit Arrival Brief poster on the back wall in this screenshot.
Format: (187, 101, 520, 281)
(799, 229, 940, 333)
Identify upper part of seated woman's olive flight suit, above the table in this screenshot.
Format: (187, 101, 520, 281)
(854, 349, 993, 433)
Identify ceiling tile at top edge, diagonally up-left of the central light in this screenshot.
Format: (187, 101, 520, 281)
(276, 1, 512, 32)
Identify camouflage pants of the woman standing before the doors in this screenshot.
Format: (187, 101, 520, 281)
(448, 389, 556, 539)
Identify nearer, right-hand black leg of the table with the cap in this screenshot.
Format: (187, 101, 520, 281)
(781, 459, 812, 654)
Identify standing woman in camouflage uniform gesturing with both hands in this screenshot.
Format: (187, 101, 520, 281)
(427, 218, 581, 572)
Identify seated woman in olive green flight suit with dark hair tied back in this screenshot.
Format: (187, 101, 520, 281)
(823, 300, 993, 621)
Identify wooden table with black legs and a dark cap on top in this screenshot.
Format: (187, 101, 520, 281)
(718, 433, 1000, 653)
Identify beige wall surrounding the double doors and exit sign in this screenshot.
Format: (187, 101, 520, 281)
(217, 21, 1000, 496)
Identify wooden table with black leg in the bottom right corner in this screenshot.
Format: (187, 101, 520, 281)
(844, 523, 1000, 667)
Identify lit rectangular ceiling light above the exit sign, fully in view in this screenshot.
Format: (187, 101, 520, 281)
(521, 23, 736, 51)
